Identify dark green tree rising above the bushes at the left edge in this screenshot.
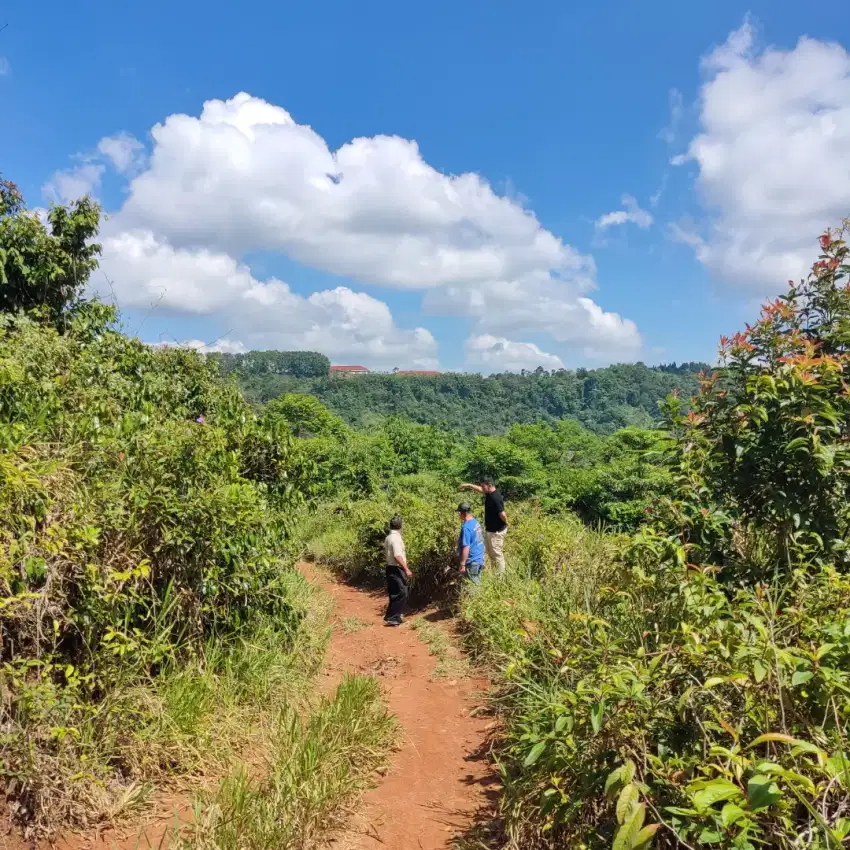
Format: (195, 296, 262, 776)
(0, 180, 100, 323)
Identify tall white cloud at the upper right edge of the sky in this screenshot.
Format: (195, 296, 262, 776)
(674, 21, 850, 291)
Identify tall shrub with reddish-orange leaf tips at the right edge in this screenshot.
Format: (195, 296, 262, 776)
(668, 222, 850, 567)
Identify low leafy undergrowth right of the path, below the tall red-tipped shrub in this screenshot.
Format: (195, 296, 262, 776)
(464, 532, 850, 847)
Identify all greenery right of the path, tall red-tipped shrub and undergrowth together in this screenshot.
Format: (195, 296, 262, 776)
(458, 225, 850, 850)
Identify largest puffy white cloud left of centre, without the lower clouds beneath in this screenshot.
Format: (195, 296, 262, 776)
(116, 93, 575, 289)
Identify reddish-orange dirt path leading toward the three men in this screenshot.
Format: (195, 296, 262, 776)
(302, 564, 498, 850)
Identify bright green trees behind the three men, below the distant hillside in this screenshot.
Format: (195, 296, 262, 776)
(282, 394, 673, 530)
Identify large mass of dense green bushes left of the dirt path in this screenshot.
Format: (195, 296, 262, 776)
(0, 304, 314, 827)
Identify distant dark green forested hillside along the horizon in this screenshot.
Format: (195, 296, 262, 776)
(216, 352, 709, 434)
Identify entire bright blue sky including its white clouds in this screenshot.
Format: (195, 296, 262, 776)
(0, 0, 850, 372)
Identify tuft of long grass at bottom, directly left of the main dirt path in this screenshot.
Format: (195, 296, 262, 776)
(175, 676, 396, 850)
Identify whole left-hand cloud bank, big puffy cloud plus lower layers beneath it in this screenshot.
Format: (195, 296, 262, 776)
(50, 93, 636, 365)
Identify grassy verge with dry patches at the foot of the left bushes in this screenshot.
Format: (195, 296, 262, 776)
(5, 572, 330, 833)
